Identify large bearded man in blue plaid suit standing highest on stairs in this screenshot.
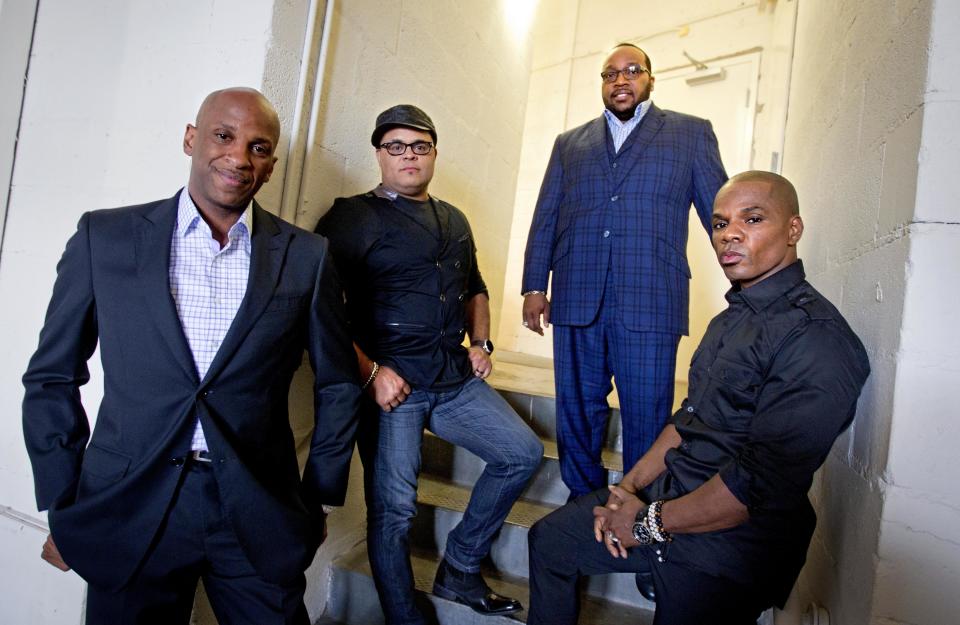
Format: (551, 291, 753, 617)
(523, 44, 727, 497)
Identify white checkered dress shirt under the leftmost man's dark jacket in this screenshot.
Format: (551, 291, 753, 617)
(170, 189, 253, 451)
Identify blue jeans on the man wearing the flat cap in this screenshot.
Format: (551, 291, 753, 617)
(361, 378, 543, 625)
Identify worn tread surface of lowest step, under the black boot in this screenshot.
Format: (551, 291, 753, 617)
(334, 543, 653, 625)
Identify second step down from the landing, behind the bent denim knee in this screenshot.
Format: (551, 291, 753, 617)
(421, 432, 623, 506)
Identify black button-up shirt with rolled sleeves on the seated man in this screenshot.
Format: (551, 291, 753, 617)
(646, 261, 870, 606)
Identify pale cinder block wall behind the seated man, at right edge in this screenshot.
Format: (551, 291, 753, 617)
(778, 0, 960, 625)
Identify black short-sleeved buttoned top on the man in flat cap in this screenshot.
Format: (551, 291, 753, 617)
(317, 187, 487, 391)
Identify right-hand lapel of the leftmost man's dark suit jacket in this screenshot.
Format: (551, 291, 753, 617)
(203, 202, 290, 383)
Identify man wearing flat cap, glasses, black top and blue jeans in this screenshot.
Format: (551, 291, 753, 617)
(317, 104, 543, 625)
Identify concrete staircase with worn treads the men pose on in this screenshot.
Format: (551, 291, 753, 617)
(321, 353, 668, 625)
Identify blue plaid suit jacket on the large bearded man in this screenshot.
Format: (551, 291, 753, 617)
(522, 105, 727, 334)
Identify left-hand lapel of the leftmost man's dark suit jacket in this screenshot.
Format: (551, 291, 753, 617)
(134, 191, 197, 381)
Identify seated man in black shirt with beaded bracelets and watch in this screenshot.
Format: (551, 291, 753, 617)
(527, 172, 870, 625)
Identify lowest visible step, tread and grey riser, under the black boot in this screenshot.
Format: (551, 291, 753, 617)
(324, 544, 653, 625)
